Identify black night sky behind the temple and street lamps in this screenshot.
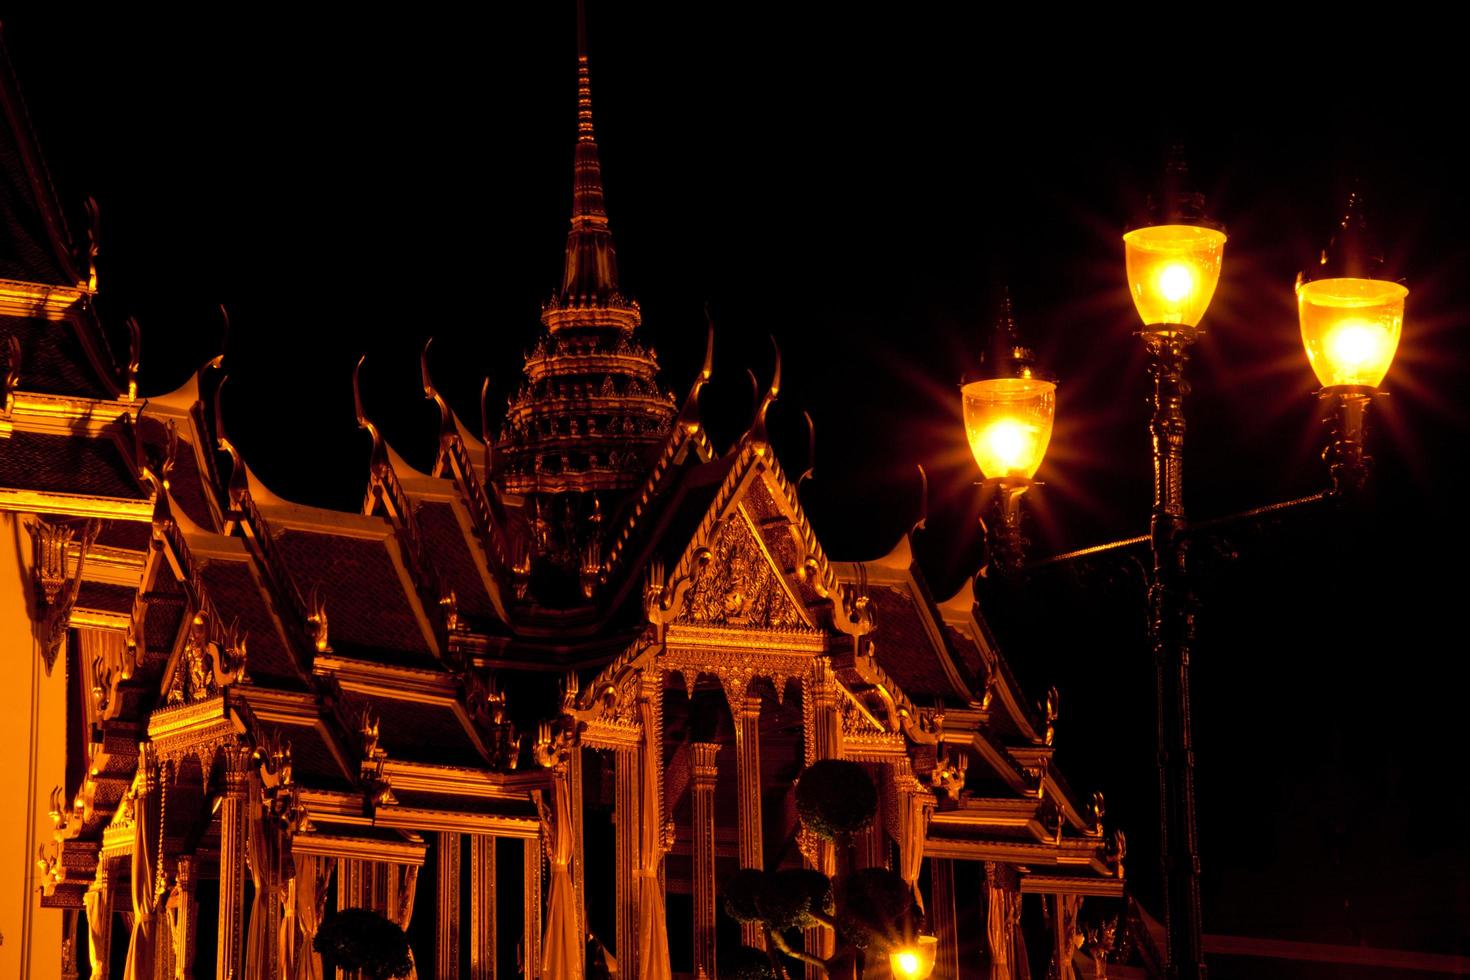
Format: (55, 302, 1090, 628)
(4, 1, 1470, 977)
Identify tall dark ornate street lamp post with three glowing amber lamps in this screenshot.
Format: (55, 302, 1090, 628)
(963, 151, 1408, 980)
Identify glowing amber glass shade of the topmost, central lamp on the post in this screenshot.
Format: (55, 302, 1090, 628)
(1123, 225, 1225, 328)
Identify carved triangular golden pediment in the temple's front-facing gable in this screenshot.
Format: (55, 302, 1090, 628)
(676, 507, 810, 629)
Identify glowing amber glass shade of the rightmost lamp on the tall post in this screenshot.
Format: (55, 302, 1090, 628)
(1297, 279, 1408, 388)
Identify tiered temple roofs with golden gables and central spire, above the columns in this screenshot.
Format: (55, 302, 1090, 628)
(0, 15, 1146, 976)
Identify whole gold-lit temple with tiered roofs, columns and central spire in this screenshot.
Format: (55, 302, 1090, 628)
(0, 13, 1141, 980)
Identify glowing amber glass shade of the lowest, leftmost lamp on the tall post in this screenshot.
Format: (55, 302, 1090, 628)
(960, 378, 1057, 479)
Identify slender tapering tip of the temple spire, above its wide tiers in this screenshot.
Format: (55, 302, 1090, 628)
(560, 0, 617, 306)
